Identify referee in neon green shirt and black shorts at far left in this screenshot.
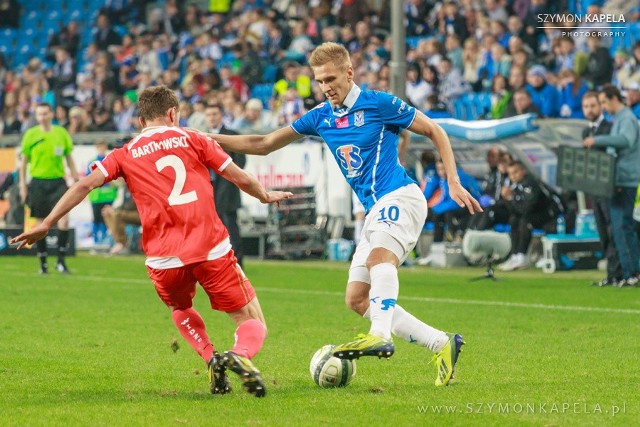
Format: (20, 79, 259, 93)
(20, 103, 78, 274)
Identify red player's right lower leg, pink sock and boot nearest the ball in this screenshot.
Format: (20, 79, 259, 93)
(222, 297, 267, 397)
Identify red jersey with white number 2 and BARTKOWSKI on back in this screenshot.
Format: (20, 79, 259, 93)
(96, 126, 231, 268)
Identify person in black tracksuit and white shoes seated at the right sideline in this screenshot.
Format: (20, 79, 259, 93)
(498, 161, 556, 271)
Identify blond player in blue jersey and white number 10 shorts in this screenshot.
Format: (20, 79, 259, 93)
(212, 43, 482, 386)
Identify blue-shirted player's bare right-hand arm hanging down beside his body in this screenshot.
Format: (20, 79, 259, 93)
(409, 110, 482, 214)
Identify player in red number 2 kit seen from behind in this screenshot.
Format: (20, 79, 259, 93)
(11, 86, 292, 397)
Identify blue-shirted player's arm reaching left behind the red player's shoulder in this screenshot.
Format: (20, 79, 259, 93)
(205, 126, 302, 156)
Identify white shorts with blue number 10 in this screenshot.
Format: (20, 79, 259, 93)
(349, 184, 427, 283)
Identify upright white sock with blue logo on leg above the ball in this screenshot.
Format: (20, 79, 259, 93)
(369, 263, 399, 339)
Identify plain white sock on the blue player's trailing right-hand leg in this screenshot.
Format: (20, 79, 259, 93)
(362, 304, 449, 353)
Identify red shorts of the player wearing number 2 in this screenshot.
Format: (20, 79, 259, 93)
(147, 251, 256, 312)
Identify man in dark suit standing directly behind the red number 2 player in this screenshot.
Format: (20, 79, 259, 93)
(205, 104, 247, 267)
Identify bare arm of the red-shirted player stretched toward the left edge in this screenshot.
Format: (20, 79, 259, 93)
(11, 169, 105, 249)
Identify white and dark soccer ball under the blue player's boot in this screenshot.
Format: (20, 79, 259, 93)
(309, 344, 356, 388)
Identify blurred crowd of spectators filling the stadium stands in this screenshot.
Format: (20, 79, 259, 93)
(0, 0, 640, 134)
